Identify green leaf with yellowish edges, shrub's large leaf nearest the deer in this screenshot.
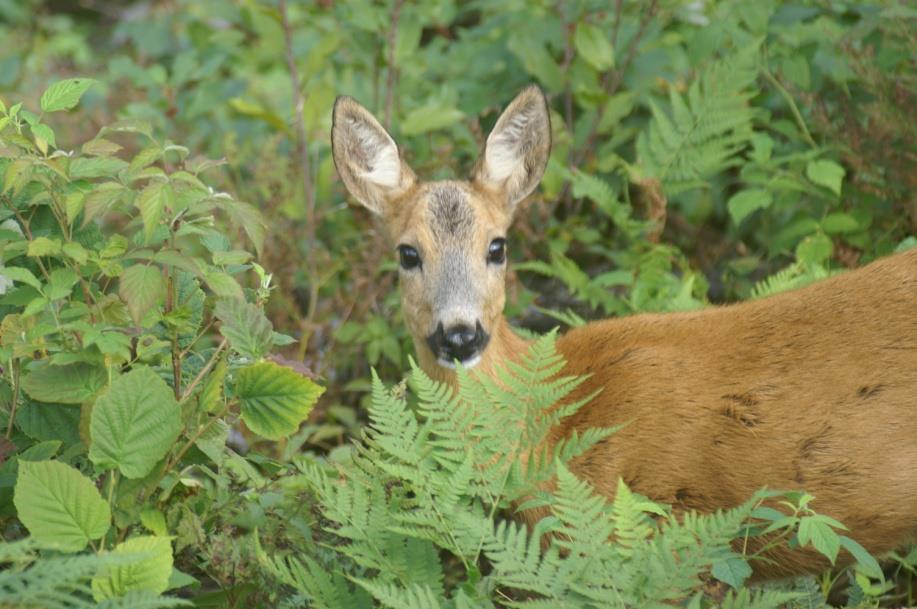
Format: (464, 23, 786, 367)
(235, 362, 324, 440)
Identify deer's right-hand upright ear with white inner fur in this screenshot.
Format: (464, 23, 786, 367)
(472, 85, 551, 209)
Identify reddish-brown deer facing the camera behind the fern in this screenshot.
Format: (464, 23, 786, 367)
(331, 85, 917, 579)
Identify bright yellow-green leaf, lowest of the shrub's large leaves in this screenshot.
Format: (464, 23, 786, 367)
(92, 535, 172, 601)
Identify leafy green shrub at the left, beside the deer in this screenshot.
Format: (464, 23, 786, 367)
(0, 79, 321, 607)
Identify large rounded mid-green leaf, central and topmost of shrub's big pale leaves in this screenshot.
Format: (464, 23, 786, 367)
(89, 367, 182, 478)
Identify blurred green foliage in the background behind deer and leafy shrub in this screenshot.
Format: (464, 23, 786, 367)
(0, 0, 917, 600)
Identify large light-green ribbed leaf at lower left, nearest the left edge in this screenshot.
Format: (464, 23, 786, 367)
(13, 461, 111, 552)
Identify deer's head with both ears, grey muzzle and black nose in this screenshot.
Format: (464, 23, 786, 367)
(331, 86, 551, 371)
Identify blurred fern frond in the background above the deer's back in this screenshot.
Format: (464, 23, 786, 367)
(637, 44, 758, 197)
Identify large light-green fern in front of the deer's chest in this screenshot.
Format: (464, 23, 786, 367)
(258, 334, 864, 609)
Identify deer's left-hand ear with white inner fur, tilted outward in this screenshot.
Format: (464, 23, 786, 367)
(331, 96, 416, 214)
